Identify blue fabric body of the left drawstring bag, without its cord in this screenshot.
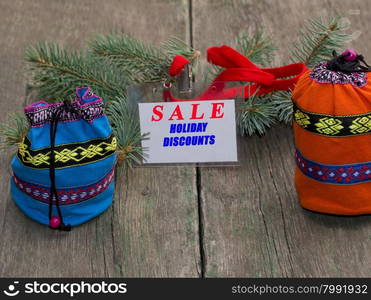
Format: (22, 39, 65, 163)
(11, 87, 116, 226)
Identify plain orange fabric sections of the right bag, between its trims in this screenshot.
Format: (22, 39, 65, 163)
(292, 70, 371, 215)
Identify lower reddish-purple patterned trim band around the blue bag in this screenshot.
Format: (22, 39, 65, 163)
(13, 169, 114, 205)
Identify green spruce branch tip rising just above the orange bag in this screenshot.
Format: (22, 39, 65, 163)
(290, 17, 350, 68)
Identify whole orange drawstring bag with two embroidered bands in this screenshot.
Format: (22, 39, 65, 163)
(292, 50, 371, 215)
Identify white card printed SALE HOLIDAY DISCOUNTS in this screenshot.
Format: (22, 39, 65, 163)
(139, 100, 238, 164)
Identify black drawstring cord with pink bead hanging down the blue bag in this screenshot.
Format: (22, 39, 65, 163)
(49, 101, 75, 231)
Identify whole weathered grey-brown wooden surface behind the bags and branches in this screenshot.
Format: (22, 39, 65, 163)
(0, 0, 371, 277)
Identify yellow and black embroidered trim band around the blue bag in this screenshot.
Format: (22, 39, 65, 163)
(17, 134, 117, 169)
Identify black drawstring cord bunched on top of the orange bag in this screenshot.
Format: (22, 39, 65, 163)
(327, 50, 371, 73)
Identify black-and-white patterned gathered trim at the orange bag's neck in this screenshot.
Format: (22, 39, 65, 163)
(309, 62, 367, 87)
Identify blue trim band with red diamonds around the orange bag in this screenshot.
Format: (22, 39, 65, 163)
(295, 150, 371, 184)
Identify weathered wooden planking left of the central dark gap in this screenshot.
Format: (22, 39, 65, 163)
(0, 0, 200, 277)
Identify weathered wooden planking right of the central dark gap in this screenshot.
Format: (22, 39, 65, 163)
(192, 0, 371, 277)
